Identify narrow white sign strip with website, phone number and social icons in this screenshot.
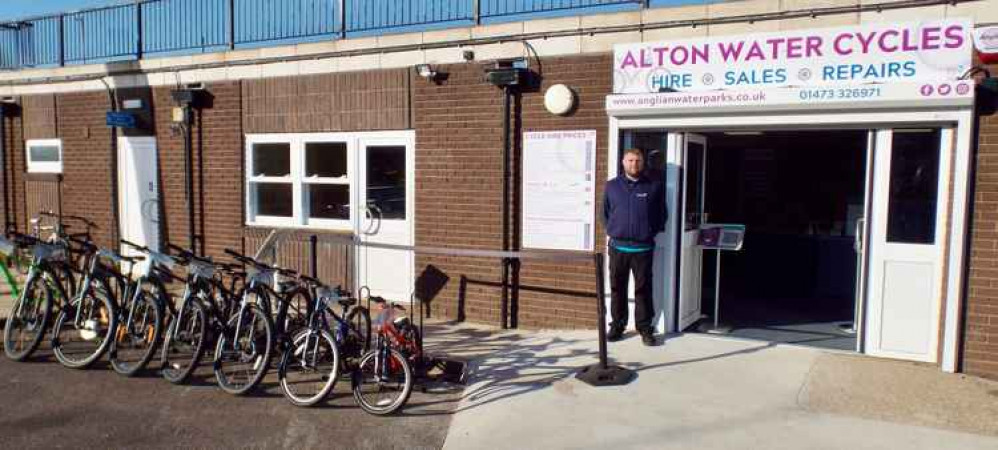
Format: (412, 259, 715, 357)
(606, 80, 974, 116)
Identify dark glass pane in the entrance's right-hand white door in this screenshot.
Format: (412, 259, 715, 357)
(887, 129, 940, 244)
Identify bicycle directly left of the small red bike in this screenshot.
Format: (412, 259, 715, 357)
(278, 274, 371, 406)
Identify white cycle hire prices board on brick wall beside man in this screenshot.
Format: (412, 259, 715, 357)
(520, 130, 596, 251)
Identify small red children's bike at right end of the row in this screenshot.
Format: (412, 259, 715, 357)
(351, 297, 422, 415)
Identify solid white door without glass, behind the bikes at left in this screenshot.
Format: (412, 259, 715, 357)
(118, 137, 159, 255)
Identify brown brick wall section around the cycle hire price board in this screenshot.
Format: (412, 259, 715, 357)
(413, 55, 612, 328)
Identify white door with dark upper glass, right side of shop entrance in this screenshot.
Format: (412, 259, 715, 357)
(864, 128, 953, 362)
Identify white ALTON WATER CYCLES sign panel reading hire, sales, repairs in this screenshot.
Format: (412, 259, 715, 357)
(613, 19, 973, 94)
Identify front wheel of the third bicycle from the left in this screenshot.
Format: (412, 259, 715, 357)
(110, 286, 163, 377)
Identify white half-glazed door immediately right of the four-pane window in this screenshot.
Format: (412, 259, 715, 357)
(355, 131, 415, 301)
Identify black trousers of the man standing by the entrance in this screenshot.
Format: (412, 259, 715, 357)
(610, 247, 655, 332)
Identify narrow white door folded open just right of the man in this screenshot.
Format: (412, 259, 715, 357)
(677, 133, 707, 331)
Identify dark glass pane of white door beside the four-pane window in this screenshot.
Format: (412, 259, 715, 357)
(367, 146, 405, 219)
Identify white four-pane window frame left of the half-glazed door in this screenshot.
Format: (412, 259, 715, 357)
(245, 133, 362, 230)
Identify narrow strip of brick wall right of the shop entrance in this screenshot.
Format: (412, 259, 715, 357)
(963, 61, 998, 379)
